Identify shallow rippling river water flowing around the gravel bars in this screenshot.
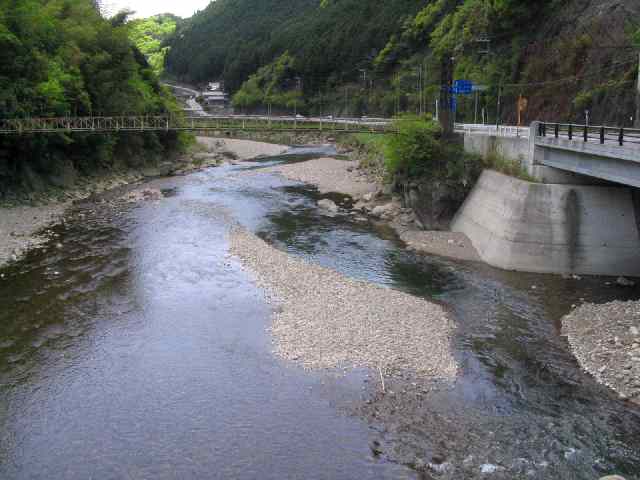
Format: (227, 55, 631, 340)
(0, 151, 640, 479)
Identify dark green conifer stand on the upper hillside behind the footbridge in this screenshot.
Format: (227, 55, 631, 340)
(167, 0, 423, 94)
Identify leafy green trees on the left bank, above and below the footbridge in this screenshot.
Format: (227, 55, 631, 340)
(0, 0, 188, 198)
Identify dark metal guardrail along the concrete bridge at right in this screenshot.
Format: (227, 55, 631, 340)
(537, 122, 640, 148)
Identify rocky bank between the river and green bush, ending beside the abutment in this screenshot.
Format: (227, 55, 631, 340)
(258, 158, 480, 261)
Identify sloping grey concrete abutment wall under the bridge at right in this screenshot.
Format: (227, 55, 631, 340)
(452, 170, 640, 276)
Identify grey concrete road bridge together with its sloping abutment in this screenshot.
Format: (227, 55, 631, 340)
(452, 122, 640, 276)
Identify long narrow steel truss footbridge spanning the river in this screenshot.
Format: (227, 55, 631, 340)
(0, 115, 395, 135)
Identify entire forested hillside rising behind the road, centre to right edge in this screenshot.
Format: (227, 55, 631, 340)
(167, 0, 640, 124)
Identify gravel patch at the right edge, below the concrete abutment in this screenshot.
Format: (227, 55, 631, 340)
(562, 301, 640, 404)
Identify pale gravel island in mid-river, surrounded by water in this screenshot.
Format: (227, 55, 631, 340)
(229, 228, 457, 380)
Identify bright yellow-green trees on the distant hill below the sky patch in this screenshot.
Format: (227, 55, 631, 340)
(127, 13, 180, 76)
